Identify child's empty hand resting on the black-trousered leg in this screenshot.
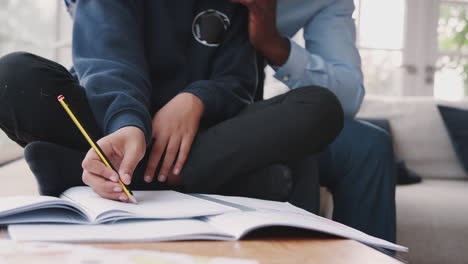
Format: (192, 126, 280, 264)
(145, 93, 203, 185)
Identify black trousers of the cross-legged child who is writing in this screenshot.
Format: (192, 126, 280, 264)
(0, 53, 343, 204)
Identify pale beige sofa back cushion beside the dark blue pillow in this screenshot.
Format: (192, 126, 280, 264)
(358, 96, 468, 179)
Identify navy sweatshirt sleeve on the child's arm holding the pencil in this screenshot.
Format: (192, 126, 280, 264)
(72, 0, 151, 140)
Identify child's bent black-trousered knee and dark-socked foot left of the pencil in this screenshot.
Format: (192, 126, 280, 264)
(0, 52, 99, 195)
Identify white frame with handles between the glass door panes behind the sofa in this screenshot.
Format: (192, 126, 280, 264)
(354, 0, 468, 97)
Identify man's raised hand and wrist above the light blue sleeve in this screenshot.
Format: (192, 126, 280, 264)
(231, 0, 291, 66)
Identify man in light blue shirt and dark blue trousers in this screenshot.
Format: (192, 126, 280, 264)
(232, 0, 395, 241)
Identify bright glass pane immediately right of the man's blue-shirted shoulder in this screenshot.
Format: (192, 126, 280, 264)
(354, 0, 406, 95)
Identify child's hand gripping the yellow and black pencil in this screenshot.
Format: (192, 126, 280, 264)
(82, 126, 146, 202)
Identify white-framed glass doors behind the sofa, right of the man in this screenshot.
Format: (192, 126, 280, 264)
(355, 0, 468, 100)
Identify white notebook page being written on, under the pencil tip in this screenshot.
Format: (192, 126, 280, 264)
(62, 187, 238, 224)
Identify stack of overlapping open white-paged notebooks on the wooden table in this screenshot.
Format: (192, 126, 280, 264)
(0, 187, 407, 251)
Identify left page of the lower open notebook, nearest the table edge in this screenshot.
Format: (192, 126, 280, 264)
(8, 219, 232, 242)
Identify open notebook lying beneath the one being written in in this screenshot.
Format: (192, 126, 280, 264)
(2, 188, 407, 251)
